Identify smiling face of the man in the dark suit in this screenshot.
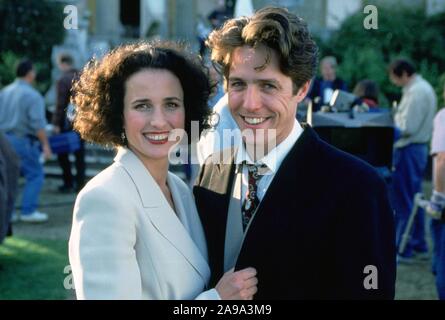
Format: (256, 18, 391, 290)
(227, 46, 310, 147)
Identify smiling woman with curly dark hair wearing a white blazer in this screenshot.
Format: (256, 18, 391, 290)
(69, 42, 257, 299)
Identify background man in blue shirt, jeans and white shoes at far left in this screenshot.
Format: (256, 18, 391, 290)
(0, 60, 51, 222)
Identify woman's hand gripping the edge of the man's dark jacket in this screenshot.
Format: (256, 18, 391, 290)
(215, 268, 258, 300)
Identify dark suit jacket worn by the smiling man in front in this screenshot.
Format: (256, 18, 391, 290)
(194, 126, 396, 299)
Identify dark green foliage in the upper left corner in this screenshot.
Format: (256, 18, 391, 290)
(0, 0, 65, 90)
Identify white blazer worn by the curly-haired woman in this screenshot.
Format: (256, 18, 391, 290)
(69, 148, 219, 299)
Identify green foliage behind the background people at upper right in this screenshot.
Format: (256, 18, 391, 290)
(322, 6, 445, 107)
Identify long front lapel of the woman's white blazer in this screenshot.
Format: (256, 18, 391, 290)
(114, 148, 210, 282)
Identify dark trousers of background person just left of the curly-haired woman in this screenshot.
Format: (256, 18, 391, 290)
(57, 140, 85, 189)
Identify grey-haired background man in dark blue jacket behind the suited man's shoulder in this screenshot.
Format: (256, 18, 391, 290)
(308, 56, 348, 112)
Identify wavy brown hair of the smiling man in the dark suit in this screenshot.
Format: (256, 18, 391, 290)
(206, 7, 318, 93)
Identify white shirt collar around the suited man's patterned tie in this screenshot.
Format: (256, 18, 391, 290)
(235, 119, 303, 174)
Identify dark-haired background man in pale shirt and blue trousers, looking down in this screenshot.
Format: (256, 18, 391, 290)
(389, 59, 437, 263)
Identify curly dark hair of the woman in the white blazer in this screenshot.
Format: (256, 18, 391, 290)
(72, 41, 210, 146)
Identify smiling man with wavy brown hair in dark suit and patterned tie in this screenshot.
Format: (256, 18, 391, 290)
(194, 7, 395, 299)
